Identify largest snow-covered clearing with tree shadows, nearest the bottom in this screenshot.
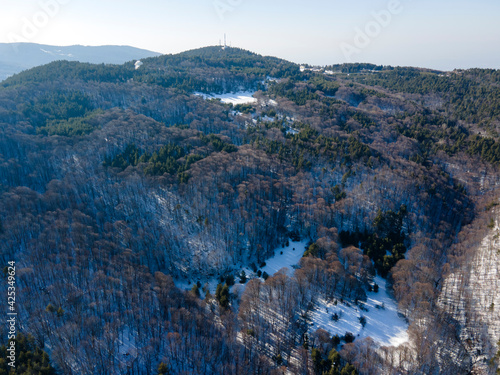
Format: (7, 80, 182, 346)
(311, 276, 408, 346)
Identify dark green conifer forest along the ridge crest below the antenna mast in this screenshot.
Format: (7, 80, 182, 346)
(0, 47, 305, 97)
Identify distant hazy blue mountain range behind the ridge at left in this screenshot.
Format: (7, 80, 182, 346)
(0, 43, 161, 81)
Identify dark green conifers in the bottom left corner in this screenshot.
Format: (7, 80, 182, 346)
(0, 334, 56, 375)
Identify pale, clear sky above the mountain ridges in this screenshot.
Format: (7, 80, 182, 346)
(0, 0, 500, 70)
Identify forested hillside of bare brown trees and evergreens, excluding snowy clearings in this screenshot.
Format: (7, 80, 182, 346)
(0, 47, 500, 375)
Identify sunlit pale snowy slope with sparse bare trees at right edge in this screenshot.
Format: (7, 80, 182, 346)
(439, 210, 500, 374)
